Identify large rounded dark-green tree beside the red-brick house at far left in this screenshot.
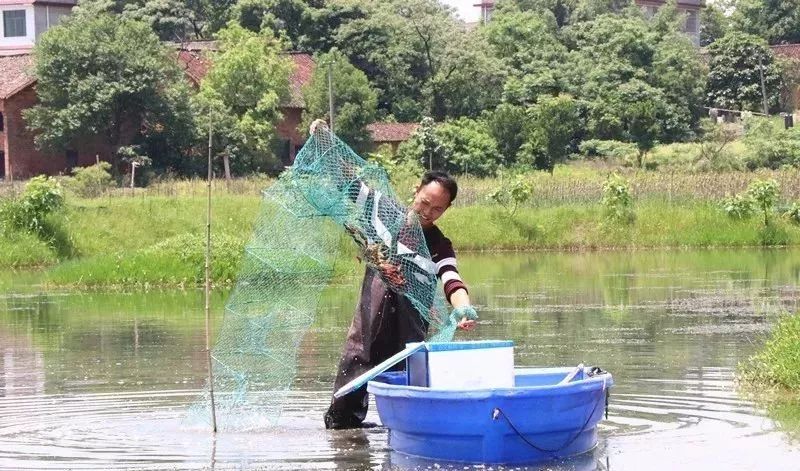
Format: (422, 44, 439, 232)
(24, 14, 191, 170)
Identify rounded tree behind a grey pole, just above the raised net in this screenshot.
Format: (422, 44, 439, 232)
(303, 49, 378, 151)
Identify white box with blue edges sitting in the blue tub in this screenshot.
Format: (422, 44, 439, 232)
(406, 340, 514, 390)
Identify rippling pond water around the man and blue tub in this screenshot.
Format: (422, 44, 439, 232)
(0, 249, 800, 470)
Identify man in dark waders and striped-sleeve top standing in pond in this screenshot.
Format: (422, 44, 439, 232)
(324, 168, 477, 429)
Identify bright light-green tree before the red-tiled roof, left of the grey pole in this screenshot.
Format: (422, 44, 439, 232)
(196, 22, 291, 173)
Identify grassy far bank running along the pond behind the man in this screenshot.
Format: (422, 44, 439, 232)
(0, 167, 800, 286)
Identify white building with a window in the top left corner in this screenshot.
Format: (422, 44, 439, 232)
(0, 0, 78, 56)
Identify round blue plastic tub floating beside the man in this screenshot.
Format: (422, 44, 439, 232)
(367, 365, 613, 464)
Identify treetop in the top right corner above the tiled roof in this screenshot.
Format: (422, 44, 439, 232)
(731, 0, 800, 44)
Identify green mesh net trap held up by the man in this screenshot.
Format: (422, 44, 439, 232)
(190, 127, 456, 430)
